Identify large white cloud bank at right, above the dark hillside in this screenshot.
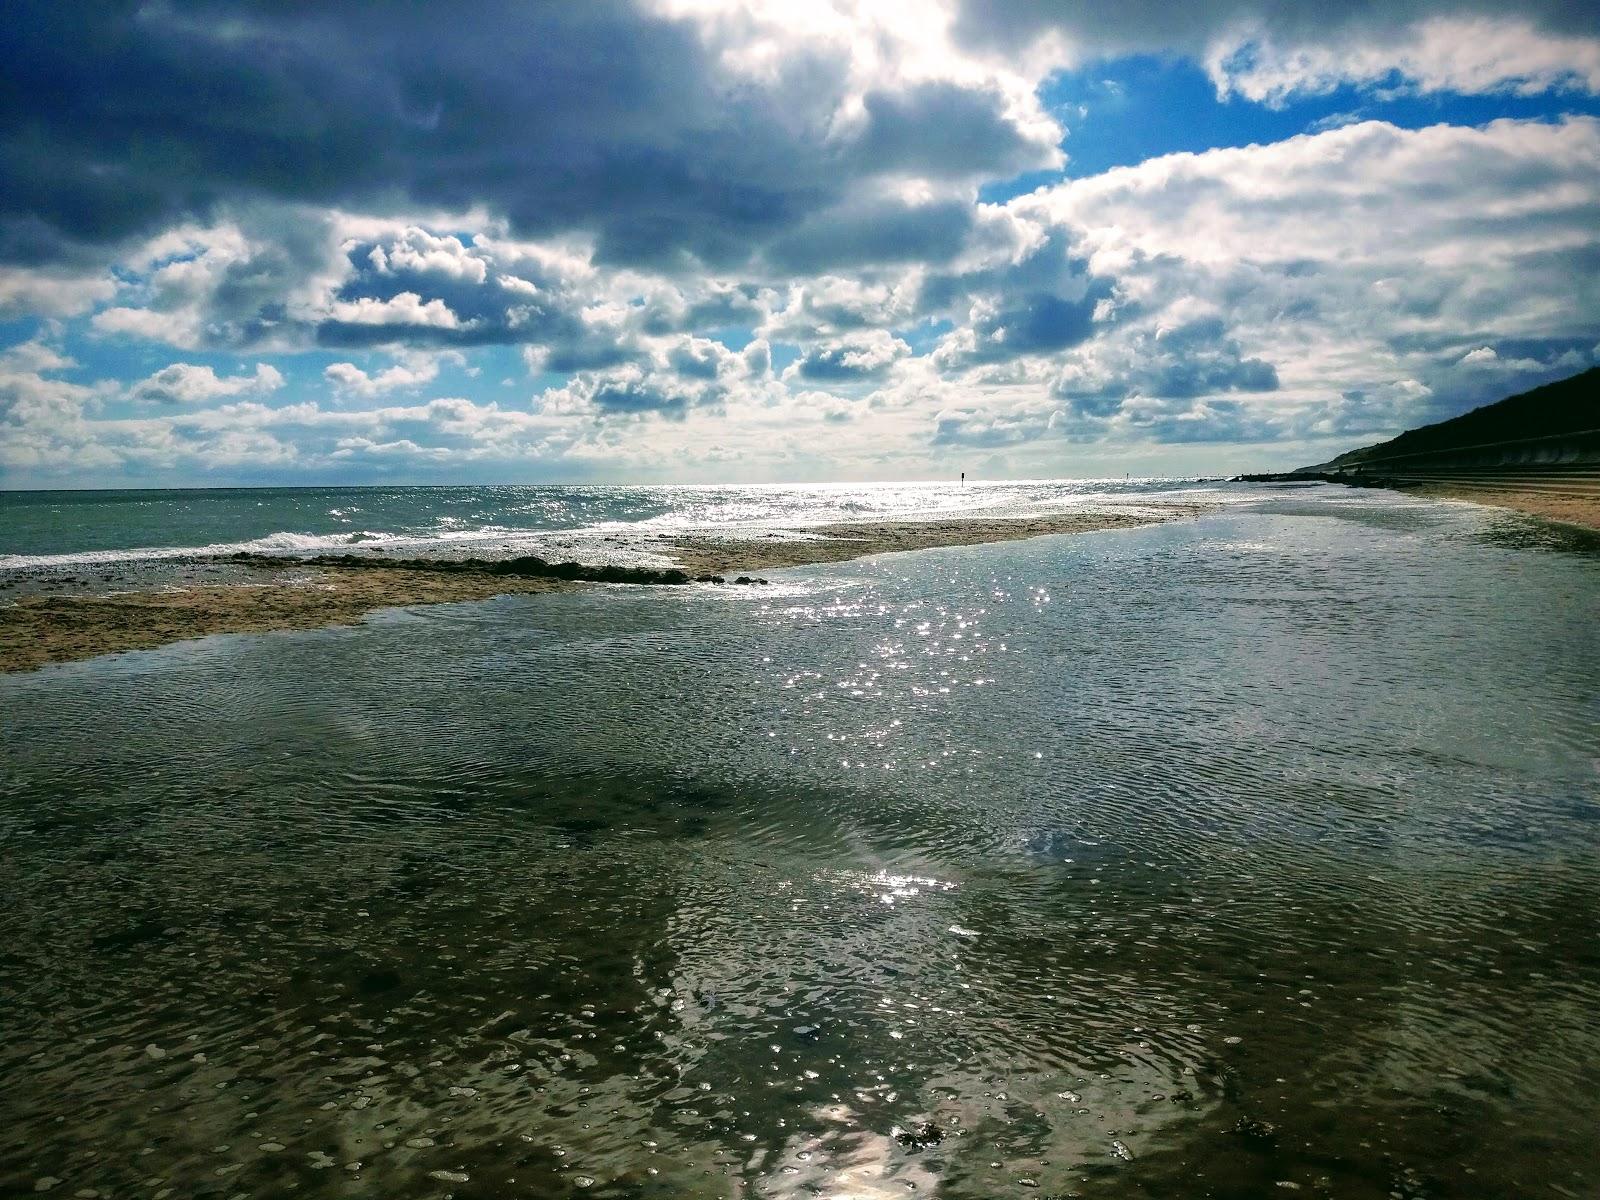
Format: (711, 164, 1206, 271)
(936, 118, 1600, 445)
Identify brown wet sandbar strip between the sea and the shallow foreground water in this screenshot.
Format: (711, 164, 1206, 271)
(0, 504, 1206, 672)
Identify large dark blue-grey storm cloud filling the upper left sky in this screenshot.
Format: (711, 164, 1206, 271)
(0, 0, 1054, 267)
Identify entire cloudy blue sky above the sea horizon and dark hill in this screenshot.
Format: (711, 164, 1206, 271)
(0, 0, 1600, 488)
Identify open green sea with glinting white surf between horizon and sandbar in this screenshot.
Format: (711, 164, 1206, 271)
(0, 480, 1240, 571)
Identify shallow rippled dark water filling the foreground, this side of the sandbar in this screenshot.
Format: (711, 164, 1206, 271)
(0, 488, 1600, 1198)
